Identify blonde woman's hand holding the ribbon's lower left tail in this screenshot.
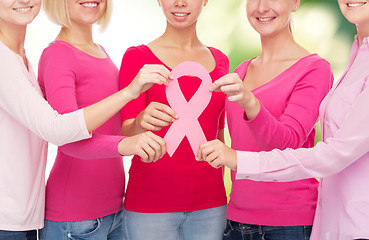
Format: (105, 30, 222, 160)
(118, 132, 167, 163)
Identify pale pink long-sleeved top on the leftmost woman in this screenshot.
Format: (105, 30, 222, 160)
(0, 42, 90, 231)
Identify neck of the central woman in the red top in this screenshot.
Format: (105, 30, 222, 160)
(160, 23, 202, 49)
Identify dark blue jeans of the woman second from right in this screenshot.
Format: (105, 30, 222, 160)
(223, 220, 312, 240)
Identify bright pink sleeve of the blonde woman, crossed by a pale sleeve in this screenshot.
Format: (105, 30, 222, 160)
(39, 46, 124, 159)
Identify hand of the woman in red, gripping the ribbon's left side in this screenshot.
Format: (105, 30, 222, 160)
(135, 102, 178, 131)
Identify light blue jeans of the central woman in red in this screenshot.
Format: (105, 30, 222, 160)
(125, 205, 226, 240)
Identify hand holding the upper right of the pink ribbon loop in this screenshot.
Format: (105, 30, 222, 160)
(210, 73, 260, 120)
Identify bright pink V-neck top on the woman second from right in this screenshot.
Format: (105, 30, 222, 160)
(226, 54, 333, 226)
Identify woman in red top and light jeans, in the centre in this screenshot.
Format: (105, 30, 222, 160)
(120, 0, 229, 240)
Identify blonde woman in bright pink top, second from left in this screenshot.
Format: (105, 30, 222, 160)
(38, 0, 170, 240)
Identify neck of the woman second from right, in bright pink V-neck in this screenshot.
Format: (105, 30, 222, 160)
(260, 27, 298, 61)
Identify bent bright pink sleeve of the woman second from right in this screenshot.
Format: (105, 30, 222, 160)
(244, 59, 333, 151)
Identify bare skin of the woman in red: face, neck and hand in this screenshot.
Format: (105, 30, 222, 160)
(122, 0, 224, 145)
